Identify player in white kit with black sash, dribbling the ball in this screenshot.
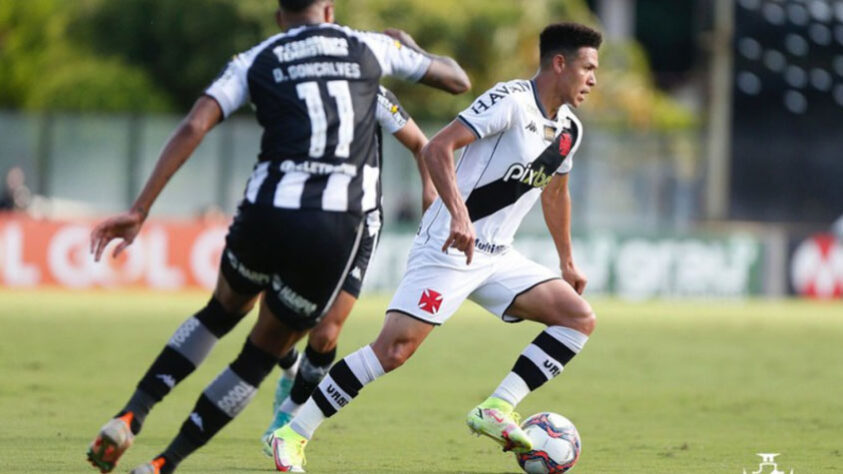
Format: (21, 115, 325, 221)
(272, 23, 602, 472)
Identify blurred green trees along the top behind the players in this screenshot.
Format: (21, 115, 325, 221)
(0, 0, 698, 129)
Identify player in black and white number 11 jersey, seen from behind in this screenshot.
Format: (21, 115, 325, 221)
(88, 0, 470, 474)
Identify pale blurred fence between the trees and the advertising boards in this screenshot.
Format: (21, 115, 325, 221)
(0, 112, 704, 232)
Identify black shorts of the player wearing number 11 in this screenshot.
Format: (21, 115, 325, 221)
(220, 203, 364, 330)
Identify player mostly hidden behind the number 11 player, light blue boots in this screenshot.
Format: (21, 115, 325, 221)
(261, 86, 436, 456)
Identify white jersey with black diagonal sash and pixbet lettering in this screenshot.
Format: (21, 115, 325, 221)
(417, 80, 582, 250)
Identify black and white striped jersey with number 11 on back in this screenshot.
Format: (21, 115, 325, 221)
(205, 24, 430, 214)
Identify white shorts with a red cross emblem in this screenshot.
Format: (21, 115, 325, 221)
(387, 244, 560, 325)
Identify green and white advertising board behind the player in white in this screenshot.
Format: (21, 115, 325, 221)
(366, 233, 768, 300)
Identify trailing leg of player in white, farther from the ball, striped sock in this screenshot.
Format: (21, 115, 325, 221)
(272, 312, 435, 472)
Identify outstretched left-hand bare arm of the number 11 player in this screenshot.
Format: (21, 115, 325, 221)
(91, 96, 222, 261)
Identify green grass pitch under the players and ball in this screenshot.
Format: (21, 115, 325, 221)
(0, 289, 843, 474)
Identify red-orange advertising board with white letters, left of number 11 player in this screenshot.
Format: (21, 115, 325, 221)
(0, 214, 227, 290)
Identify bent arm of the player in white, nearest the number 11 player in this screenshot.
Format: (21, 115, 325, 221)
(422, 120, 477, 264)
